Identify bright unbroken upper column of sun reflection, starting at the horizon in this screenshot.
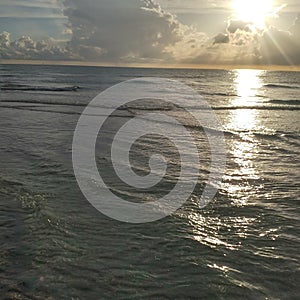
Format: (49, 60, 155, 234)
(224, 70, 263, 206)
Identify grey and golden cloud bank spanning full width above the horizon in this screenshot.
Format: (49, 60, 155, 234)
(0, 0, 300, 65)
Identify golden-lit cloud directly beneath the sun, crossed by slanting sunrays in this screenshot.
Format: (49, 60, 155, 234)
(195, 15, 300, 65)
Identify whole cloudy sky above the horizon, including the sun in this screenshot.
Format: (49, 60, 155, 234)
(0, 0, 300, 66)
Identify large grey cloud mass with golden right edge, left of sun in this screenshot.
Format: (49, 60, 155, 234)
(65, 0, 193, 61)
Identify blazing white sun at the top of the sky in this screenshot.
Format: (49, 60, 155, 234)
(233, 0, 274, 28)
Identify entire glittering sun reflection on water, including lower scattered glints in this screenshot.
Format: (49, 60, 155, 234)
(188, 70, 263, 248)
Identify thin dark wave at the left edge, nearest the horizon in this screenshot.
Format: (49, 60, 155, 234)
(0, 84, 81, 92)
